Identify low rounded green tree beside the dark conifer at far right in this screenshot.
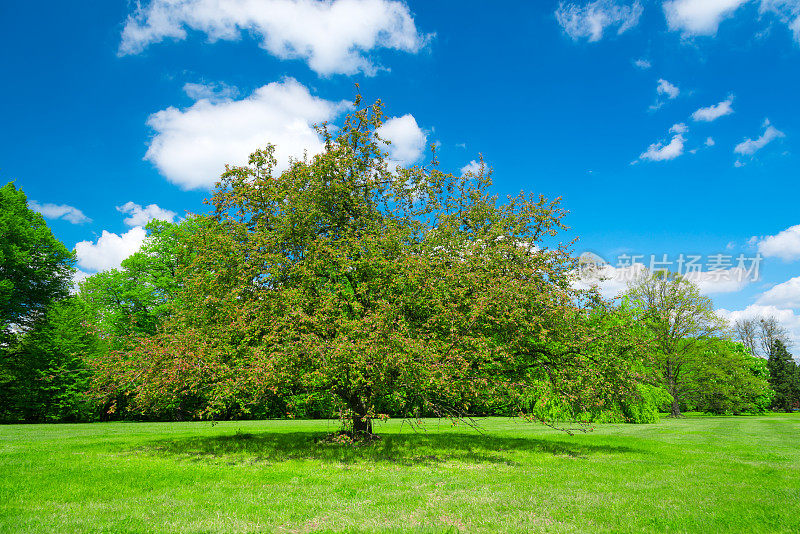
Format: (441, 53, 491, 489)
(679, 339, 773, 415)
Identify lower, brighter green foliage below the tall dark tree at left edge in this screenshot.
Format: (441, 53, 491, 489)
(0, 297, 101, 422)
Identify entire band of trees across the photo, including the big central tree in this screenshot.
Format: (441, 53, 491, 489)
(0, 105, 800, 433)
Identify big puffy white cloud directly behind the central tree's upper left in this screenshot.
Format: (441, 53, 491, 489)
(145, 78, 347, 189)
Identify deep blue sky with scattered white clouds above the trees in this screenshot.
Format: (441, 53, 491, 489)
(0, 0, 800, 352)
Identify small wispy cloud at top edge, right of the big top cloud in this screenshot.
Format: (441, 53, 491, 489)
(556, 0, 644, 42)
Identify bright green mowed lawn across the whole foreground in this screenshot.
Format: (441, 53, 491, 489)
(0, 414, 800, 533)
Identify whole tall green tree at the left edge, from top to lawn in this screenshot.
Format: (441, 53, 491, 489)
(0, 183, 96, 421)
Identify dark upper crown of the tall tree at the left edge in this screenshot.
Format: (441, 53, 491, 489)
(0, 183, 75, 342)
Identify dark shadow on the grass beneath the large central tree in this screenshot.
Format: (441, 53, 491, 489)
(139, 432, 640, 465)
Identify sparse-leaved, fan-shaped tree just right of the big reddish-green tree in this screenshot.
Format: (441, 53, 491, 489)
(626, 271, 724, 417)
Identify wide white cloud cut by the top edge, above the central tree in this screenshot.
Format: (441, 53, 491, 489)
(119, 0, 429, 75)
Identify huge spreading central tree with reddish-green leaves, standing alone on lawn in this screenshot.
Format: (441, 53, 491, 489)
(97, 99, 638, 434)
